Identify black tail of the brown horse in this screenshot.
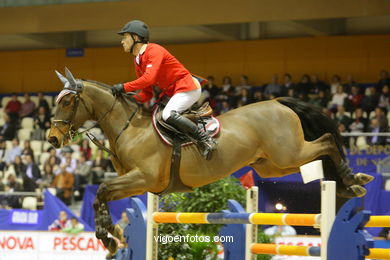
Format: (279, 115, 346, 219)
(276, 97, 347, 208)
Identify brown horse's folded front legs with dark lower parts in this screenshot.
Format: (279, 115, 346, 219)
(94, 170, 148, 255)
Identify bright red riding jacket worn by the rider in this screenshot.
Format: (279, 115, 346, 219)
(124, 43, 197, 103)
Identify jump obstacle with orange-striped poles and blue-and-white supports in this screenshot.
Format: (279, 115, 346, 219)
(125, 181, 390, 260)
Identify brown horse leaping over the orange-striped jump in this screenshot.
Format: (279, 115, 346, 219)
(48, 69, 371, 253)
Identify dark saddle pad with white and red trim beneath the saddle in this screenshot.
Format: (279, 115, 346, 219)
(152, 105, 221, 146)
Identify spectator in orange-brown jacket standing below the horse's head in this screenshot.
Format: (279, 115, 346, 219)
(52, 164, 74, 205)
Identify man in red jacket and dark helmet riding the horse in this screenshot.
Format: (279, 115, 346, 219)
(112, 20, 216, 159)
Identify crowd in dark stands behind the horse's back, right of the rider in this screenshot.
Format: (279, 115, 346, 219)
(193, 71, 390, 148)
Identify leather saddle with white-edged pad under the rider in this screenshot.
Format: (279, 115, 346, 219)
(152, 102, 221, 146)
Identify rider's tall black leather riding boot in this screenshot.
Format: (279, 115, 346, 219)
(166, 111, 216, 160)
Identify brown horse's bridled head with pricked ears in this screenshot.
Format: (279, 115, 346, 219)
(48, 68, 90, 148)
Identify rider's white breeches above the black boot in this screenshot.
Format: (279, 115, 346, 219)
(162, 79, 202, 121)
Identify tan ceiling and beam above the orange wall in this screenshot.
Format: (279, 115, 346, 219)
(0, 0, 390, 50)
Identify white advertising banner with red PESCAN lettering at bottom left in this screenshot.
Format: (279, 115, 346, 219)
(0, 231, 107, 260)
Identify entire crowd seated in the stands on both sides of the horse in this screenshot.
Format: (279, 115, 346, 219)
(0, 71, 390, 208)
